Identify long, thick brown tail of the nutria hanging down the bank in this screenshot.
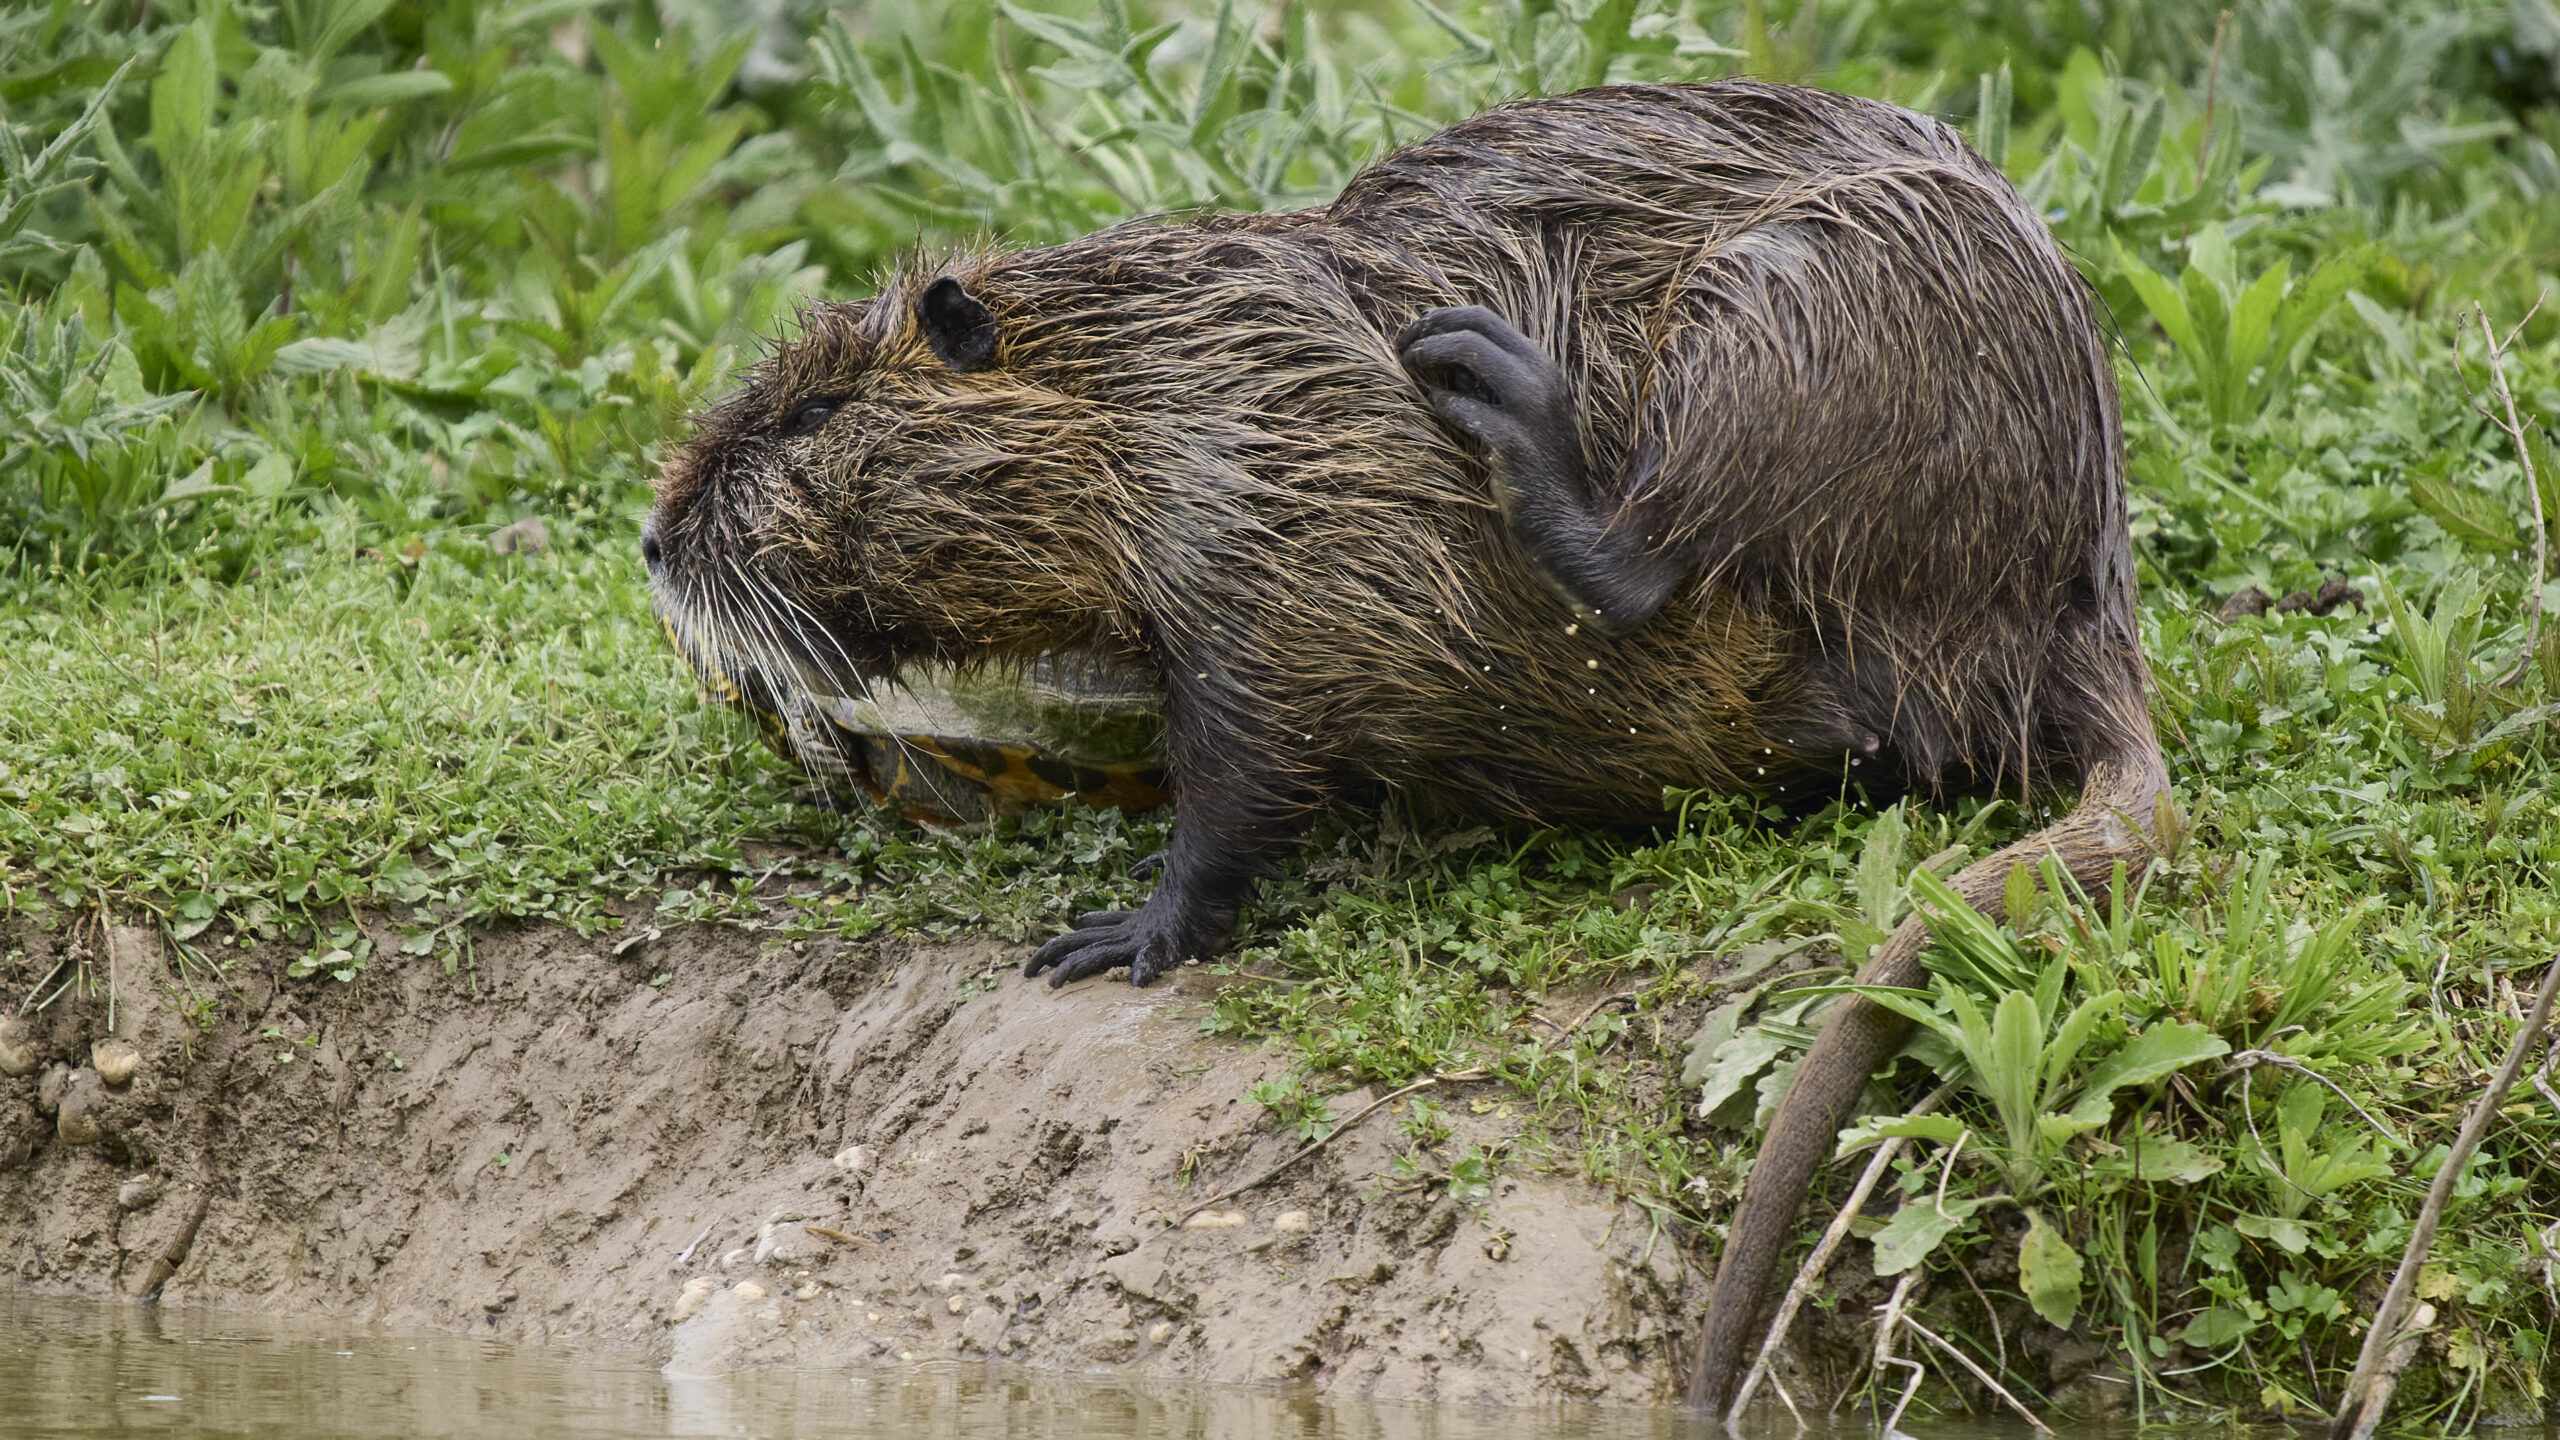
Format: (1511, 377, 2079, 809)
(1690, 725, 2168, 1414)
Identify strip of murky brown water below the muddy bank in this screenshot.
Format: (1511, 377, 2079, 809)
(0, 1294, 2058, 1440)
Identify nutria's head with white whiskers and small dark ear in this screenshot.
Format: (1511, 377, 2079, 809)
(640, 274, 1126, 694)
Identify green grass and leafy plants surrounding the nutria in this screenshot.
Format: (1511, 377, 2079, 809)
(15, 0, 2560, 1427)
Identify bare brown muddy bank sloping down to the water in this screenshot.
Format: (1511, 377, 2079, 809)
(0, 925, 1705, 1404)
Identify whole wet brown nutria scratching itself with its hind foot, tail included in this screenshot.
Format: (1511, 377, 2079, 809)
(643, 82, 2166, 1407)
